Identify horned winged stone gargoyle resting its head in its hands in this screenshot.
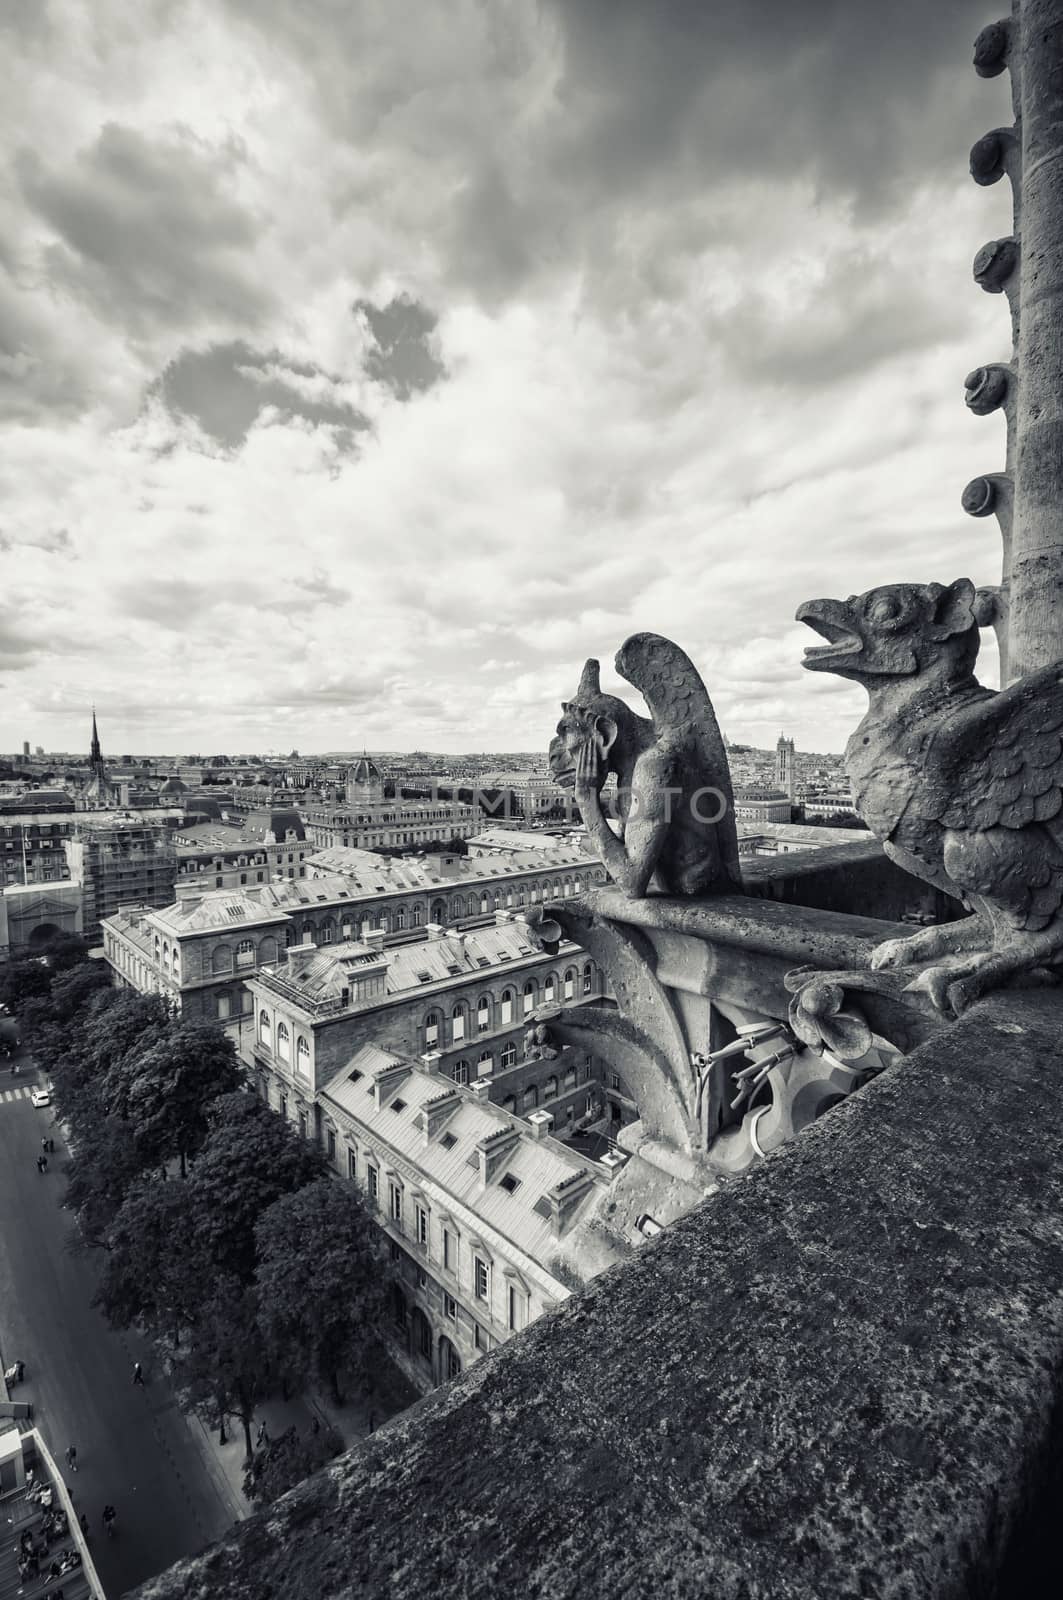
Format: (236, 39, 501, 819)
(549, 634, 741, 899)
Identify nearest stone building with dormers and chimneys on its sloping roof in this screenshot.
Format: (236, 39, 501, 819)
(315, 1043, 629, 1390)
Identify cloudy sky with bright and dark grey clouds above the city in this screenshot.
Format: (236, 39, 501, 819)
(0, 0, 1010, 754)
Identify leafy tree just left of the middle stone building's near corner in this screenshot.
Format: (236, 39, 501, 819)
(122, 1019, 243, 1178)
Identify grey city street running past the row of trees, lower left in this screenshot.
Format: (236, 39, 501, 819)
(0, 1054, 234, 1600)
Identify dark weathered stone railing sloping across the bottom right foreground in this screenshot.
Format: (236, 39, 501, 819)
(128, 990, 1063, 1600)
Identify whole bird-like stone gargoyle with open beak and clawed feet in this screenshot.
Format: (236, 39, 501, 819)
(797, 578, 1063, 1016)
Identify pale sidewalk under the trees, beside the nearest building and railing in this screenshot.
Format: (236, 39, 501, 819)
(180, 1370, 419, 1522)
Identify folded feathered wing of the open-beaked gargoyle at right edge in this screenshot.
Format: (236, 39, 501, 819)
(917, 664, 1063, 834)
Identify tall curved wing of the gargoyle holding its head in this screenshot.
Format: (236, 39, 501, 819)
(615, 634, 741, 883)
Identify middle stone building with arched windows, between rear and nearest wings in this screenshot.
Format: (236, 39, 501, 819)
(239, 912, 607, 1131)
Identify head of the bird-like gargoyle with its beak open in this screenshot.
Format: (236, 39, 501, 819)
(797, 578, 993, 683)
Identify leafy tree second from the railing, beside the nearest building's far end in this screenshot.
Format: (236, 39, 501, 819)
(189, 1091, 328, 1283)
